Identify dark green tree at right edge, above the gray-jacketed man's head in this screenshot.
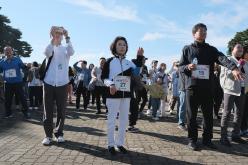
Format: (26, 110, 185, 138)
(227, 29, 248, 55)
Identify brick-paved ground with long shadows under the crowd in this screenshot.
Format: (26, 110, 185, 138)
(0, 97, 248, 165)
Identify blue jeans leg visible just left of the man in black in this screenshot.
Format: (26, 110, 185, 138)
(178, 91, 186, 125)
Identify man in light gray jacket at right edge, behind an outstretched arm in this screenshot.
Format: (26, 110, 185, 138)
(220, 43, 248, 147)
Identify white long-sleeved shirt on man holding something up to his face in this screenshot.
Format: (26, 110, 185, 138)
(44, 42, 74, 87)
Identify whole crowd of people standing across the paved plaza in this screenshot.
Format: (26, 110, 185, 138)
(0, 23, 248, 155)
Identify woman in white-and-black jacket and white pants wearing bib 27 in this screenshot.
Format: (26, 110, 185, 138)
(101, 36, 143, 155)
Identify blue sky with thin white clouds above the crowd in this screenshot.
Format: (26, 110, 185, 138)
(0, 0, 248, 67)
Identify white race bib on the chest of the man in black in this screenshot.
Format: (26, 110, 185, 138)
(191, 65, 209, 80)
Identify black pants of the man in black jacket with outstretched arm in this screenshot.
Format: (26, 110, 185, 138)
(186, 88, 213, 142)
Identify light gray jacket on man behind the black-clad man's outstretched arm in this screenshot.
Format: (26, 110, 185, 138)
(220, 56, 246, 96)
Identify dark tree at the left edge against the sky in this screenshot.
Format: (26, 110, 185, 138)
(0, 7, 33, 57)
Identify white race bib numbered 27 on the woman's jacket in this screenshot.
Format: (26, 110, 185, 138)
(114, 76, 131, 92)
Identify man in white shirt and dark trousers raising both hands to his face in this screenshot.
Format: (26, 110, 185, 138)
(42, 26, 74, 145)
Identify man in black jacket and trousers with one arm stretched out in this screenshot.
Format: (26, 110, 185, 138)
(179, 23, 242, 150)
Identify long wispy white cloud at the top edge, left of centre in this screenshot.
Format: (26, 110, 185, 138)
(65, 0, 141, 22)
